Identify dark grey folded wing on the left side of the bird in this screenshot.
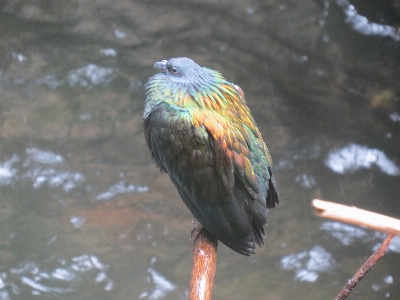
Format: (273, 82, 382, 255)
(144, 103, 255, 255)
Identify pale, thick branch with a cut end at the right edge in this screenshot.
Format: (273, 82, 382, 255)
(312, 199, 400, 235)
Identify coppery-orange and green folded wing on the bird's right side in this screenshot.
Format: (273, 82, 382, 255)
(194, 110, 278, 223)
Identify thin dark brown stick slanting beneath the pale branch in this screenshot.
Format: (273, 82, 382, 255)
(335, 234, 394, 300)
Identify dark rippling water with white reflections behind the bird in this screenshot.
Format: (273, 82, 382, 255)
(0, 0, 400, 300)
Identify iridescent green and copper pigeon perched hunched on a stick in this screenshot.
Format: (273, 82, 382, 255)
(143, 57, 279, 256)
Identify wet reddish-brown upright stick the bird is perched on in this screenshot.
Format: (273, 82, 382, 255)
(189, 228, 218, 300)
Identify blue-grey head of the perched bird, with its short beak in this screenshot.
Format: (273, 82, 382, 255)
(154, 57, 212, 86)
